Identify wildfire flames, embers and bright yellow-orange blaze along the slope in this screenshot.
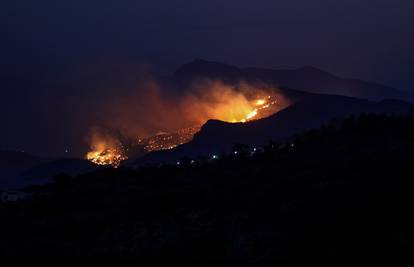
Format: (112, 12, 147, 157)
(86, 91, 280, 168)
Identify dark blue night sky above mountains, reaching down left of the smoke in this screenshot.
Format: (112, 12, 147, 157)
(0, 0, 414, 155)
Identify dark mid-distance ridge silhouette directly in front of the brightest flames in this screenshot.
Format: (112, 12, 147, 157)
(135, 95, 413, 165)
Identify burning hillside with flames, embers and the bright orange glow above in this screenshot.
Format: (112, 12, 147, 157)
(86, 84, 287, 170)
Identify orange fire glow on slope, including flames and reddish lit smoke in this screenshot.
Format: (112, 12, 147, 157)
(85, 82, 289, 170)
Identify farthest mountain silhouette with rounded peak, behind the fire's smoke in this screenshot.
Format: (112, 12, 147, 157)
(174, 59, 414, 101)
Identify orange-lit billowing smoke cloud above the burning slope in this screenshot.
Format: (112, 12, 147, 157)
(84, 75, 289, 165)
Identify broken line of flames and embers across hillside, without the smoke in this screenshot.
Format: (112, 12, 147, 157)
(86, 96, 278, 168)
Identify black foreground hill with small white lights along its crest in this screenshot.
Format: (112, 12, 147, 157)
(0, 115, 414, 266)
